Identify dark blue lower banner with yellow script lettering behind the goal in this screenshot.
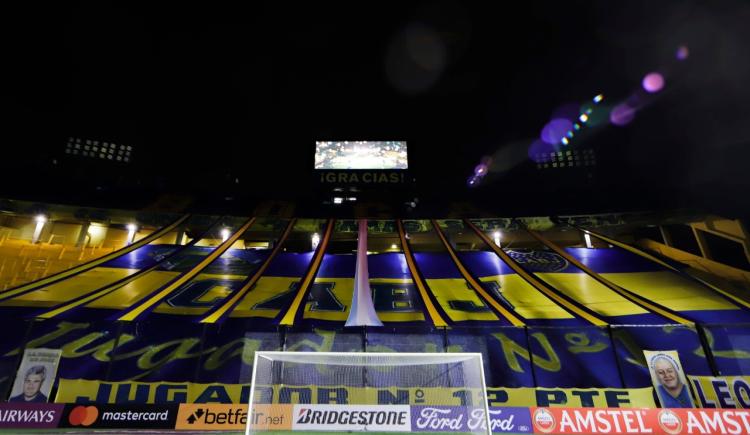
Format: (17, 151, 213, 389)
(0, 316, 724, 392)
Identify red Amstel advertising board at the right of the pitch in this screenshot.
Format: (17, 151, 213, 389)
(531, 408, 750, 435)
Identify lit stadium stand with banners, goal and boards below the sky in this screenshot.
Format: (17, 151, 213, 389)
(0, 201, 750, 433)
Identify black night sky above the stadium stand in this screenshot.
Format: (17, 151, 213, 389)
(0, 0, 750, 215)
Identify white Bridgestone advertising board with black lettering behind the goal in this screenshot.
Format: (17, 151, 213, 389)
(292, 405, 411, 432)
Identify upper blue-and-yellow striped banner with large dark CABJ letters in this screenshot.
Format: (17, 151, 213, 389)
(0, 245, 750, 326)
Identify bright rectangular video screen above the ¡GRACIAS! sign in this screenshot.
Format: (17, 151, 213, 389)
(315, 141, 408, 169)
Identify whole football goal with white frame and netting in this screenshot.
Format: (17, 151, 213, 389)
(247, 352, 490, 435)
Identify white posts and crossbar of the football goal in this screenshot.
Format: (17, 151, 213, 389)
(245, 351, 492, 435)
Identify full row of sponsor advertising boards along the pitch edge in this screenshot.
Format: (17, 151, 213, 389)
(0, 403, 750, 435)
